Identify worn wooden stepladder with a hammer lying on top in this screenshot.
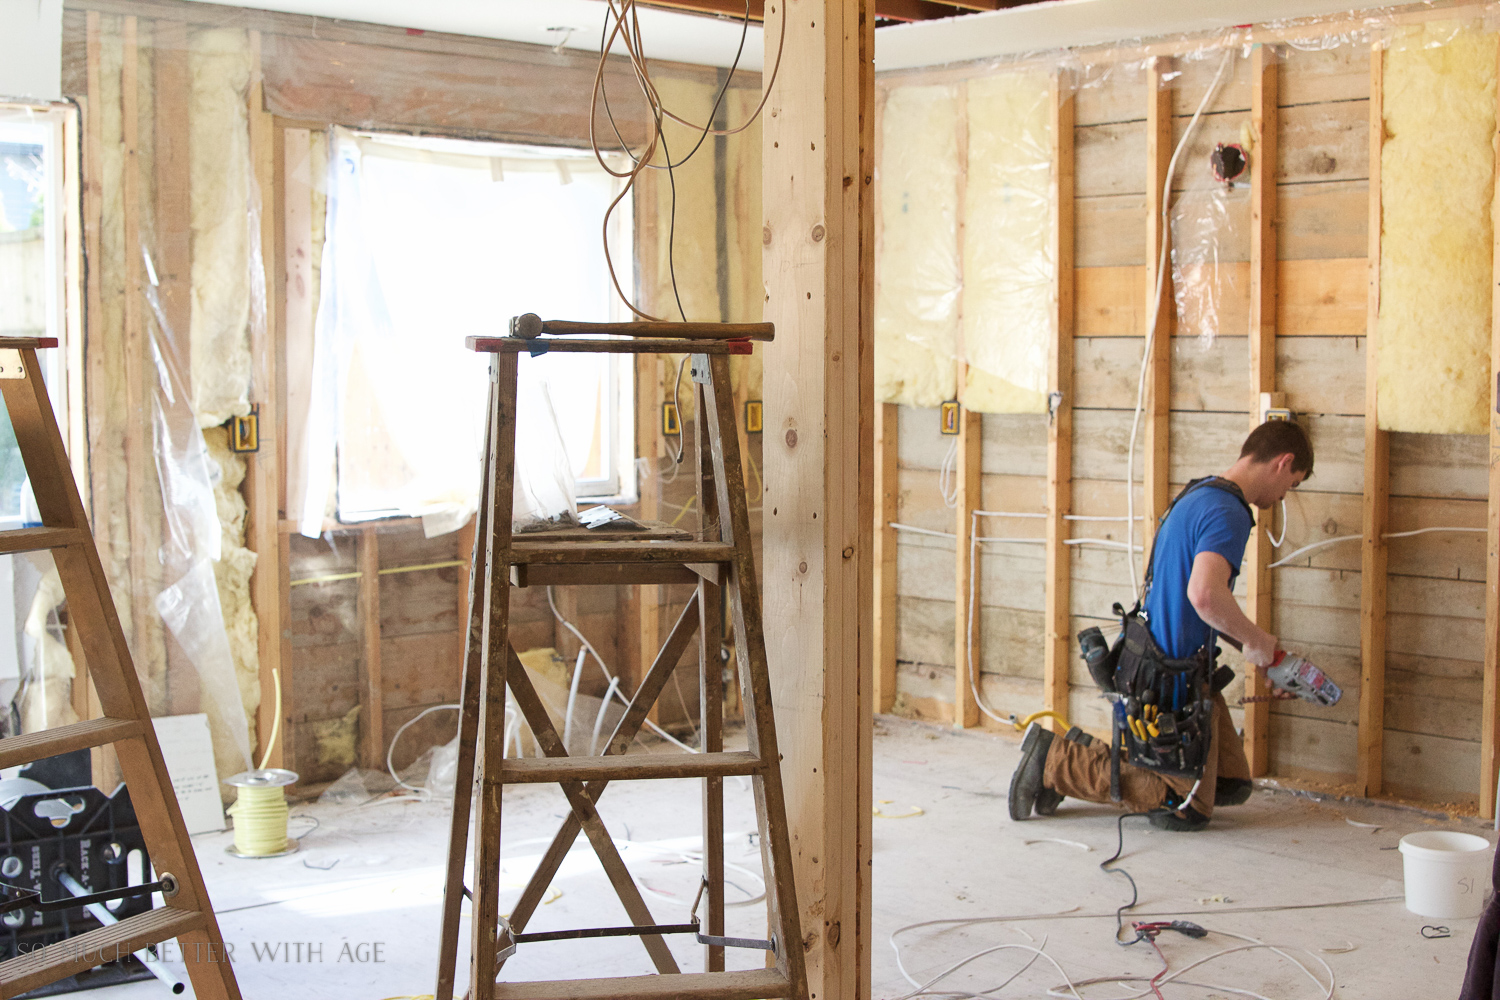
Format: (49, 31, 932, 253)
(437, 313, 807, 1000)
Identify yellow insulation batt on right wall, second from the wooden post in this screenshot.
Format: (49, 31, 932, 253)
(963, 72, 1058, 414)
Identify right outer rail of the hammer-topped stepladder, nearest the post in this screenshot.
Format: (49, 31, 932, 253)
(704, 355, 807, 999)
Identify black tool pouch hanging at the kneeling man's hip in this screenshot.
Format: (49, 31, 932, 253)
(1112, 612, 1214, 784)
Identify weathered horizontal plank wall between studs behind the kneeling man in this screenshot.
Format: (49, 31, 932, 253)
(879, 25, 1490, 801)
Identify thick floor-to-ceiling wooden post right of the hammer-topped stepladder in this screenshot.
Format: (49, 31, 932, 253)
(762, 0, 875, 1000)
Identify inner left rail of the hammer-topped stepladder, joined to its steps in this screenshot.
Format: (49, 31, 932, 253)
(470, 354, 516, 1000)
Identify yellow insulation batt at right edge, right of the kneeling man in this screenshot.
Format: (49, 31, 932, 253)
(1377, 22, 1500, 433)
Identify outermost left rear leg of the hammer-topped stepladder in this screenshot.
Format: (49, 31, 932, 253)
(434, 387, 504, 1000)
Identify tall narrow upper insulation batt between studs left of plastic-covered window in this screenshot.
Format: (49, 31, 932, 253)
(188, 28, 260, 427)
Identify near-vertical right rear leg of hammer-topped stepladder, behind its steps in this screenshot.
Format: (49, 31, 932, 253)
(695, 385, 725, 972)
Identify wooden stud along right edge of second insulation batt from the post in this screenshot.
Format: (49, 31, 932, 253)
(1043, 70, 1074, 729)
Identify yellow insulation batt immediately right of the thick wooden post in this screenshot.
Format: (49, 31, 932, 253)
(875, 85, 960, 406)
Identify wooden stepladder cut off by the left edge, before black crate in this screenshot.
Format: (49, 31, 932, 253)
(0, 337, 240, 1000)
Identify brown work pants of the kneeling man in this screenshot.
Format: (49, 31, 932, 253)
(1041, 694, 1250, 816)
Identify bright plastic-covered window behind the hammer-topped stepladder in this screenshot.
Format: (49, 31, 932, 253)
(303, 129, 635, 534)
